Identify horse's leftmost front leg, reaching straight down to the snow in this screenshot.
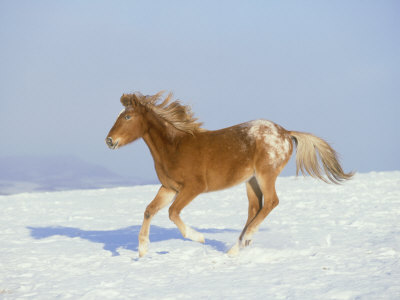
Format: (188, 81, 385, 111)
(139, 186, 176, 257)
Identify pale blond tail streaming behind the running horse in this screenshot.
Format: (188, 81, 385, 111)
(289, 131, 354, 184)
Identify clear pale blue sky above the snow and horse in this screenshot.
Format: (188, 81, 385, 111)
(0, 0, 400, 181)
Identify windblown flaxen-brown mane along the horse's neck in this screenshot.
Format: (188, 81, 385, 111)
(121, 91, 205, 135)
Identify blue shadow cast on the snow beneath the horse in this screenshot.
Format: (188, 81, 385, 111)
(27, 225, 241, 256)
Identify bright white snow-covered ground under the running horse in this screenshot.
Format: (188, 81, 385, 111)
(0, 171, 400, 299)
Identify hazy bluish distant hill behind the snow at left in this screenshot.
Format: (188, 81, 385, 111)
(0, 156, 150, 195)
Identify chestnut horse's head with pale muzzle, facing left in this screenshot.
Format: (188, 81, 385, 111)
(106, 94, 145, 149)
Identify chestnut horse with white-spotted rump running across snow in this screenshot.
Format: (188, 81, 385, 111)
(106, 92, 354, 257)
